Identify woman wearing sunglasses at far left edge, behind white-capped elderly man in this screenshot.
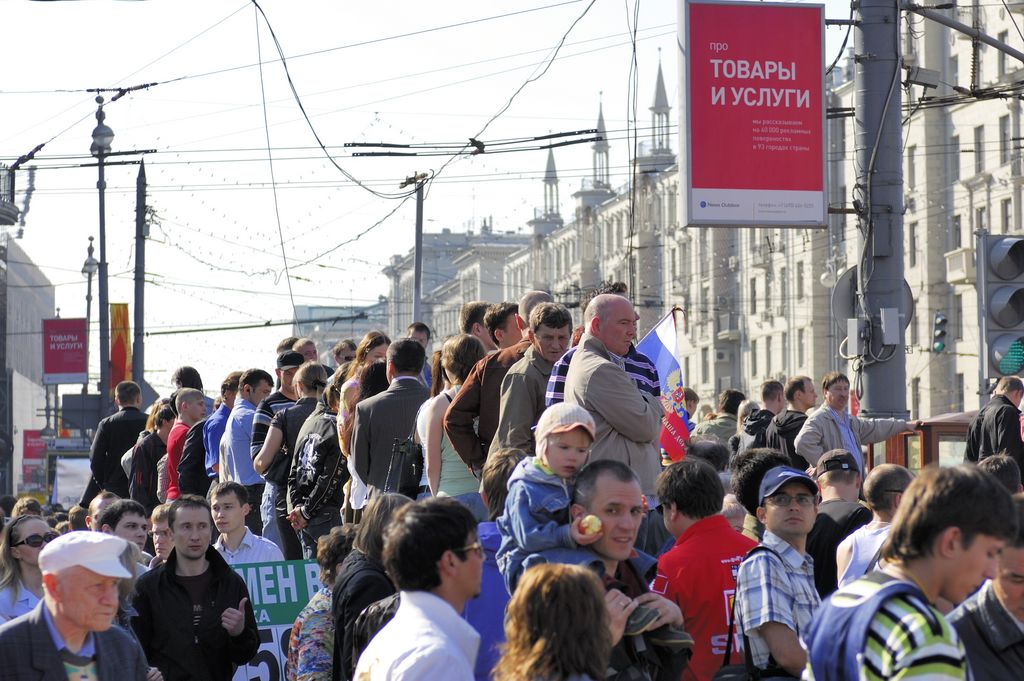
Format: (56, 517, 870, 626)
(0, 515, 57, 624)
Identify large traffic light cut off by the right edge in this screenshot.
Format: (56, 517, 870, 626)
(978, 235, 1024, 377)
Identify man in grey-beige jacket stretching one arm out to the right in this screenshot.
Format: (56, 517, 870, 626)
(796, 372, 921, 475)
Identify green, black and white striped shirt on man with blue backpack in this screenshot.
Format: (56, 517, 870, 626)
(804, 579, 968, 681)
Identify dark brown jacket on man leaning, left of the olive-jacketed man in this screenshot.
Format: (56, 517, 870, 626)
(444, 340, 529, 470)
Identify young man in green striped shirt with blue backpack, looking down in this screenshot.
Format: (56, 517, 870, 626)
(803, 466, 1017, 681)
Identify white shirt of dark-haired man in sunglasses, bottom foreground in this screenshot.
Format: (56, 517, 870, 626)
(355, 591, 480, 681)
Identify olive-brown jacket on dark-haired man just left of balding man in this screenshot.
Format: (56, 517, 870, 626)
(487, 346, 553, 456)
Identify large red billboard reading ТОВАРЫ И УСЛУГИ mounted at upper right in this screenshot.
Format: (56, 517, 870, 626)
(681, 0, 827, 227)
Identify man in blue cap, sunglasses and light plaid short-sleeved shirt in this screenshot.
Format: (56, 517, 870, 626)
(735, 466, 821, 679)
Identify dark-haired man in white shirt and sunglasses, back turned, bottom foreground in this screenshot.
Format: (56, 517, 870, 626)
(355, 497, 483, 681)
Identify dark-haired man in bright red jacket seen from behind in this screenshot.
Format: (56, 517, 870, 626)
(651, 459, 757, 681)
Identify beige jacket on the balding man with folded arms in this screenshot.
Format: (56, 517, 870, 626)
(565, 334, 665, 495)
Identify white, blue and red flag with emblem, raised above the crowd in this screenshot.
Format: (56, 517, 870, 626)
(637, 308, 690, 461)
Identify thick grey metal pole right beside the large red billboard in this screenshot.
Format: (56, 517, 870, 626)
(847, 0, 910, 419)
